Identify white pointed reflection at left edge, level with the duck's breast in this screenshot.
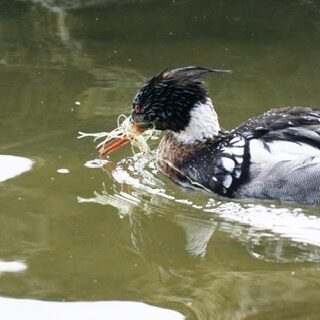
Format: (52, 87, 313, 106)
(0, 155, 33, 182)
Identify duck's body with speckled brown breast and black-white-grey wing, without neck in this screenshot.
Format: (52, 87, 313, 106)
(157, 107, 320, 204)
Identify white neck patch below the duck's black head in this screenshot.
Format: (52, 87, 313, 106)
(173, 98, 220, 144)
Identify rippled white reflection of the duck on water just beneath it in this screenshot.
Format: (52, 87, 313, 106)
(78, 154, 320, 262)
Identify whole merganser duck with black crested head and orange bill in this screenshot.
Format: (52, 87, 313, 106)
(99, 66, 320, 204)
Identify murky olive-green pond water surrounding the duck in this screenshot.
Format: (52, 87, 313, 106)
(0, 0, 320, 320)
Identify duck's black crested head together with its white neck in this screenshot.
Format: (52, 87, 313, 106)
(99, 66, 231, 154)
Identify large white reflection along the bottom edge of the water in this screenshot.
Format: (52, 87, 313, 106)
(0, 298, 185, 320)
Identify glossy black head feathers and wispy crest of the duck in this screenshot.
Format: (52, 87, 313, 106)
(132, 66, 231, 132)
